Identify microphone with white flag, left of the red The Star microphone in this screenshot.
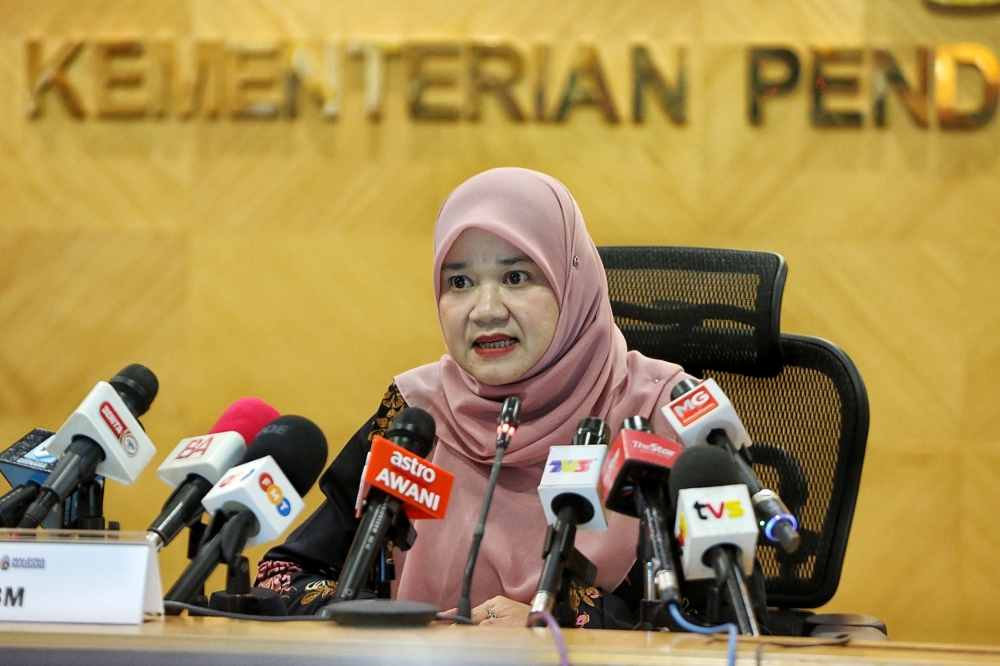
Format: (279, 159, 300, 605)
(530, 417, 608, 613)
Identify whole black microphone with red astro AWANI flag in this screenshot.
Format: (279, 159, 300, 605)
(332, 407, 455, 600)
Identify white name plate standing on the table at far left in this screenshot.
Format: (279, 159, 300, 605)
(0, 530, 163, 624)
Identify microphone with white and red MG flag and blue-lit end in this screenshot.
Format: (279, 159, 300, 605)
(662, 379, 802, 553)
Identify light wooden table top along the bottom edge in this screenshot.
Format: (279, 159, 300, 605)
(0, 616, 1000, 666)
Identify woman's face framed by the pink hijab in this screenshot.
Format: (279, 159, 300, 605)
(438, 228, 559, 386)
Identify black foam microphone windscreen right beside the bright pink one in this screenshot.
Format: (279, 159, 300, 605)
(240, 414, 327, 497)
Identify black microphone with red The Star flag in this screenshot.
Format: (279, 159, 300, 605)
(601, 416, 684, 603)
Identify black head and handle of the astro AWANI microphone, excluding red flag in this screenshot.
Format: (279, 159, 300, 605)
(330, 407, 435, 603)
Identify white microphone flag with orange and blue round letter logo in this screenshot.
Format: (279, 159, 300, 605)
(201, 456, 300, 546)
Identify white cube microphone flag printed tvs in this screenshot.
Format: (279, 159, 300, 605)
(674, 484, 758, 580)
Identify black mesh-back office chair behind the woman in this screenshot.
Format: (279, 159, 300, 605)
(598, 247, 885, 638)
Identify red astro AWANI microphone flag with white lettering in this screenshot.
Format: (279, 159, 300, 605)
(358, 435, 455, 520)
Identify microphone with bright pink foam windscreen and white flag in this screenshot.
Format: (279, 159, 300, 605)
(146, 398, 280, 550)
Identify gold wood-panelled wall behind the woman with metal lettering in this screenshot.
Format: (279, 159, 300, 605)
(0, 0, 1000, 643)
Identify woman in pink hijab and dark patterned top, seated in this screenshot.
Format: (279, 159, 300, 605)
(258, 168, 686, 626)
